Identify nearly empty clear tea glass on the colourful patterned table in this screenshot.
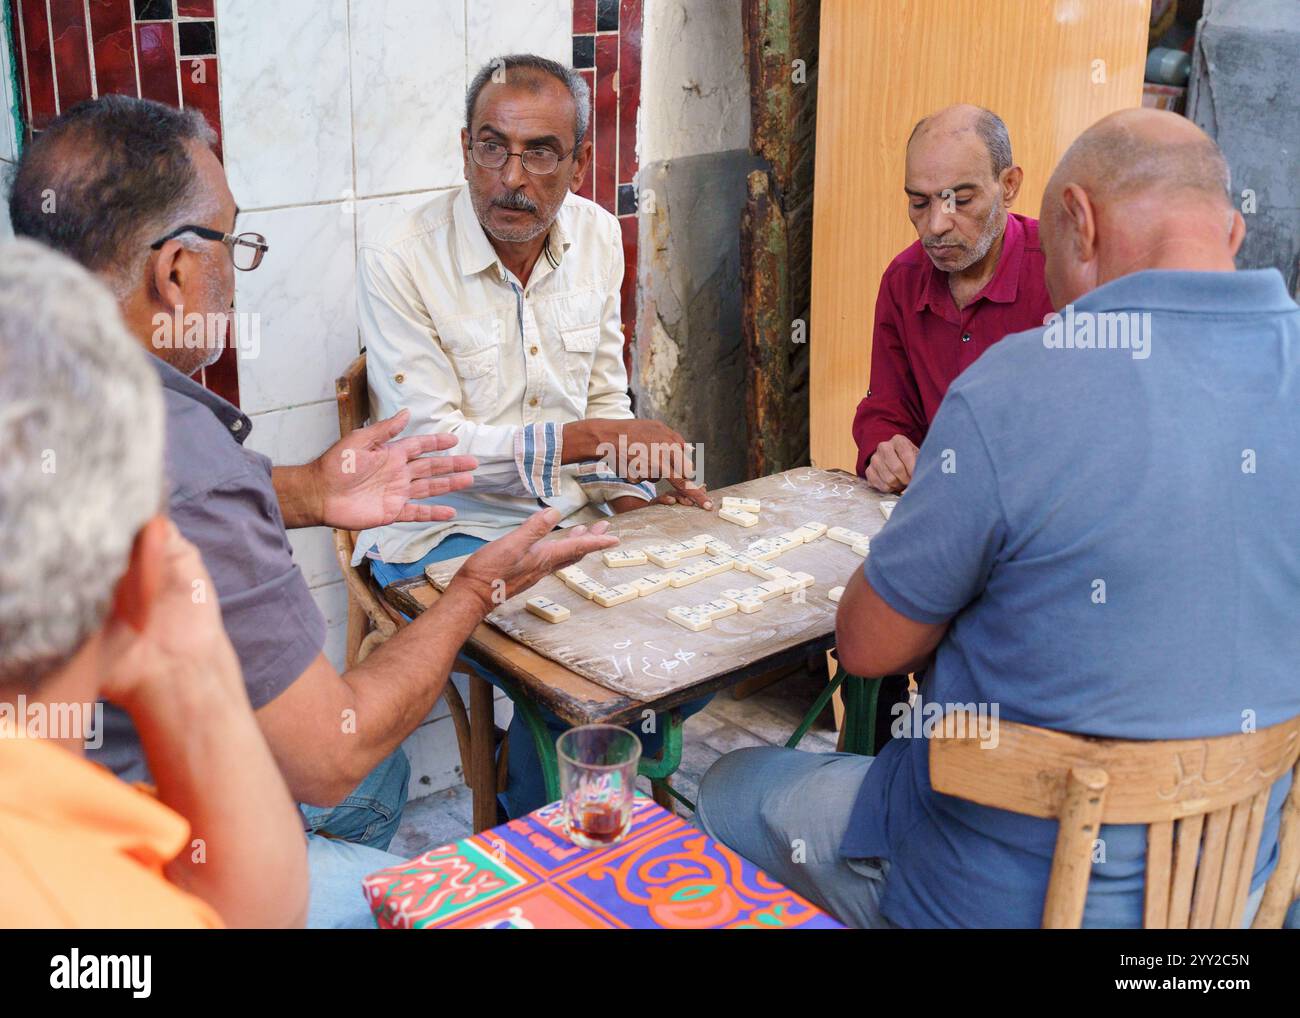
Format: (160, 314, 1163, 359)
(555, 724, 641, 848)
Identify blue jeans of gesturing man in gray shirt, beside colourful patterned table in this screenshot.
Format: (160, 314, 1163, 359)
(298, 722, 411, 930)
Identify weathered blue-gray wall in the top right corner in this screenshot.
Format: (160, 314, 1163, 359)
(1187, 0, 1300, 294)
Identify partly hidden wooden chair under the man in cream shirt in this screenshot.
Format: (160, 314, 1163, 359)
(334, 352, 471, 775)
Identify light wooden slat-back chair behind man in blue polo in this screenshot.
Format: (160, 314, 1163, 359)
(930, 711, 1300, 930)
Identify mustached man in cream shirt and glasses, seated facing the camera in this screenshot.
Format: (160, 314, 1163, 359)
(356, 55, 712, 815)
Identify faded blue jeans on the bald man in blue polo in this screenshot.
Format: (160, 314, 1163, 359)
(696, 746, 893, 930)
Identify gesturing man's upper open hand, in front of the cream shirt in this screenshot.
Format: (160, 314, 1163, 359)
(312, 410, 478, 530)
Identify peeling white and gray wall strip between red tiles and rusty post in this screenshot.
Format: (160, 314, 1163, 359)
(632, 0, 759, 488)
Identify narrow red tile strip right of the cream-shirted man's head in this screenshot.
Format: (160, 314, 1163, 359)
(573, 0, 644, 376)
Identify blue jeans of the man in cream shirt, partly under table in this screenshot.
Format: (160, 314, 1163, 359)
(369, 534, 712, 818)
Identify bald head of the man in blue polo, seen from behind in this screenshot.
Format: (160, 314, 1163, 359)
(1039, 109, 1245, 307)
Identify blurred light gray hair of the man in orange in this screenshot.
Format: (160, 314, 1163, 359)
(0, 241, 164, 688)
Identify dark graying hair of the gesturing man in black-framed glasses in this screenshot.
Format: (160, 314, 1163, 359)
(9, 95, 217, 299)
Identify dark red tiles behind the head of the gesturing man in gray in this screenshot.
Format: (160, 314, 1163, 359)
(9, 0, 239, 403)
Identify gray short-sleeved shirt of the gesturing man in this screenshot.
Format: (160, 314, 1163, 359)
(88, 358, 325, 781)
